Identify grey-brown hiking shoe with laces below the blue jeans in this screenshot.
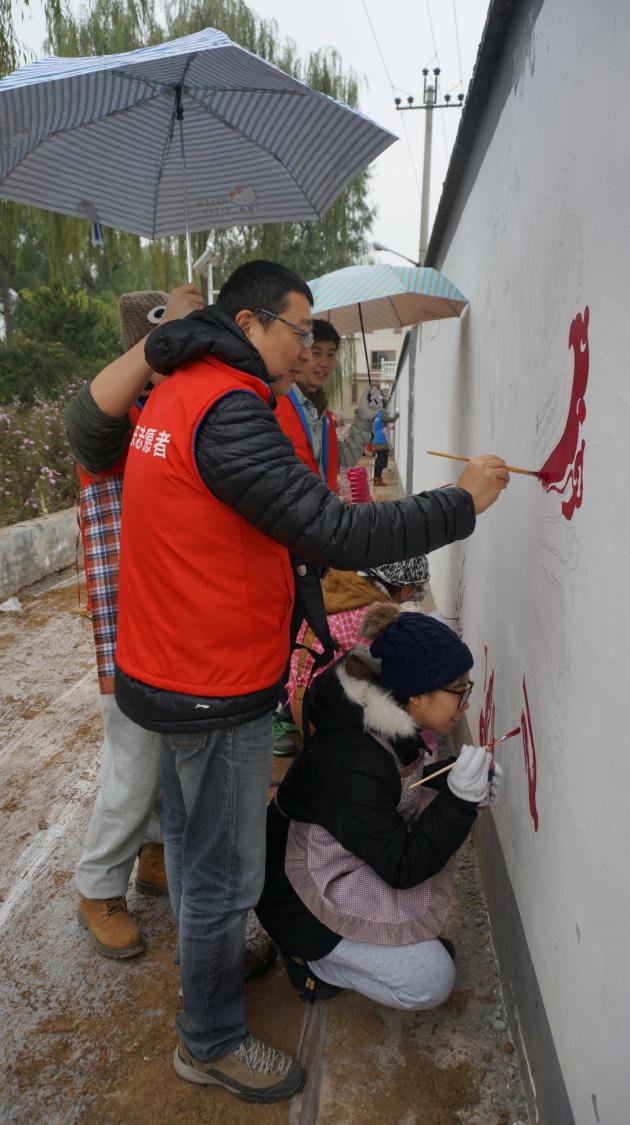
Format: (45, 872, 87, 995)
(173, 1035, 305, 1101)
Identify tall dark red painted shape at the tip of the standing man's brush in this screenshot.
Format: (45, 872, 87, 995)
(539, 305, 590, 520)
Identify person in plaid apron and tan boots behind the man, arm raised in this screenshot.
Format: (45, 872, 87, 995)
(66, 285, 203, 961)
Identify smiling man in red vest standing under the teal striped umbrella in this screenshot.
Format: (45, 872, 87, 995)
(276, 321, 383, 492)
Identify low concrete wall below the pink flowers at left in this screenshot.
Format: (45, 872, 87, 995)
(0, 507, 79, 602)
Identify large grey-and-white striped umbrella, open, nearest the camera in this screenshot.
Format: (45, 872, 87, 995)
(0, 28, 396, 272)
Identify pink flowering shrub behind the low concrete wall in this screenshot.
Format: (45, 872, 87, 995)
(0, 384, 78, 527)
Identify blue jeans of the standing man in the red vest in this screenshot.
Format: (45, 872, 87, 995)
(162, 714, 272, 1062)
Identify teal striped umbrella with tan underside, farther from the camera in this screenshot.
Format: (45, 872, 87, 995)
(308, 266, 468, 335)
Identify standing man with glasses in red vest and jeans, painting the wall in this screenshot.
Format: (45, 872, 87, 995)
(115, 262, 509, 1103)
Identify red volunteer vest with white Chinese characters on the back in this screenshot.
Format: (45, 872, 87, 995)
(116, 359, 294, 696)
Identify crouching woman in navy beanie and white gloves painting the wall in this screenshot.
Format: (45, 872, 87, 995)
(257, 604, 501, 1009)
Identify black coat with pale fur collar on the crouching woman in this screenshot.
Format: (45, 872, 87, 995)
(257, 658, 477, 961)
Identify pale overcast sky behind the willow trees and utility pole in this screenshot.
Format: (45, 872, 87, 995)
(16, 0, 488, 261)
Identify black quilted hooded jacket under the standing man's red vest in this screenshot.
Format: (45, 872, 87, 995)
(115, 306, 475, 732)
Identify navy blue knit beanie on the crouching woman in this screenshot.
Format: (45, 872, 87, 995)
(370, 612, 475, 699)
